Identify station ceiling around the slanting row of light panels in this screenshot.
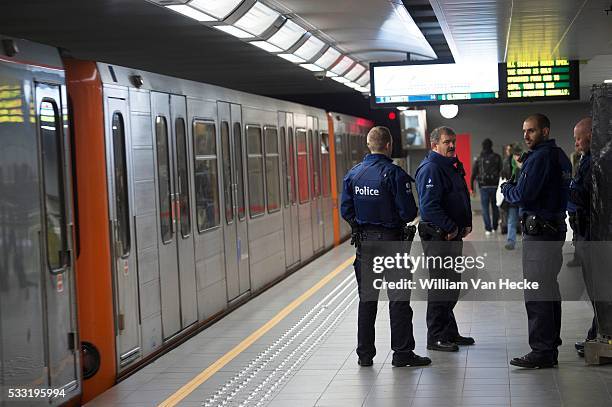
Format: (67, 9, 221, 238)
(0, 0, 612, 111)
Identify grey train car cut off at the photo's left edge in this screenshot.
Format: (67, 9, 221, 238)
(0, 36, 81, 406)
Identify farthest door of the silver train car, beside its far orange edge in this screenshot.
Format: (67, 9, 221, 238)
(308, 116, 324, 253)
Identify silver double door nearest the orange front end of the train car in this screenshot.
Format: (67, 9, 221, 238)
(151, 92, 197, 339)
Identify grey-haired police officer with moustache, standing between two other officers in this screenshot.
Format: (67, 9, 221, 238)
(416, 127, 474, 352)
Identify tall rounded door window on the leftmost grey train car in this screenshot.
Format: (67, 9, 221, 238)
(39, 98, 68, 271)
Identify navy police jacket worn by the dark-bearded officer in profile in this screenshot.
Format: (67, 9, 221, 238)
(502, 139, 572, 222)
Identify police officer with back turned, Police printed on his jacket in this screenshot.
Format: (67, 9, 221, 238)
(341, 126, 431, 367)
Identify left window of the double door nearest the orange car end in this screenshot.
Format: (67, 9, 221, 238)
(155, 116, 173, 243)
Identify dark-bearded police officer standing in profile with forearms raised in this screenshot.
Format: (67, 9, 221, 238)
(502, 113, 572, 368)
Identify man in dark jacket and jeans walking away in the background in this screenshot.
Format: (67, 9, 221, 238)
(470, 138, 502, 236)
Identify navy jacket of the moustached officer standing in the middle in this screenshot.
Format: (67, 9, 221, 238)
(416, 151, 472, 232)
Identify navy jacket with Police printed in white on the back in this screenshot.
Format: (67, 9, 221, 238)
(340, 154, 417, 229)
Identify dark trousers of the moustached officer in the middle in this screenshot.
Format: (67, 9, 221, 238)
(421, 236, 463, 344)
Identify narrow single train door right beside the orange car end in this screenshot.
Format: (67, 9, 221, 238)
(105, 93, 141, 367)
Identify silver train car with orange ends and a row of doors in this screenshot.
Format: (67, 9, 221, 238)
(64, 59, 371, 401)
